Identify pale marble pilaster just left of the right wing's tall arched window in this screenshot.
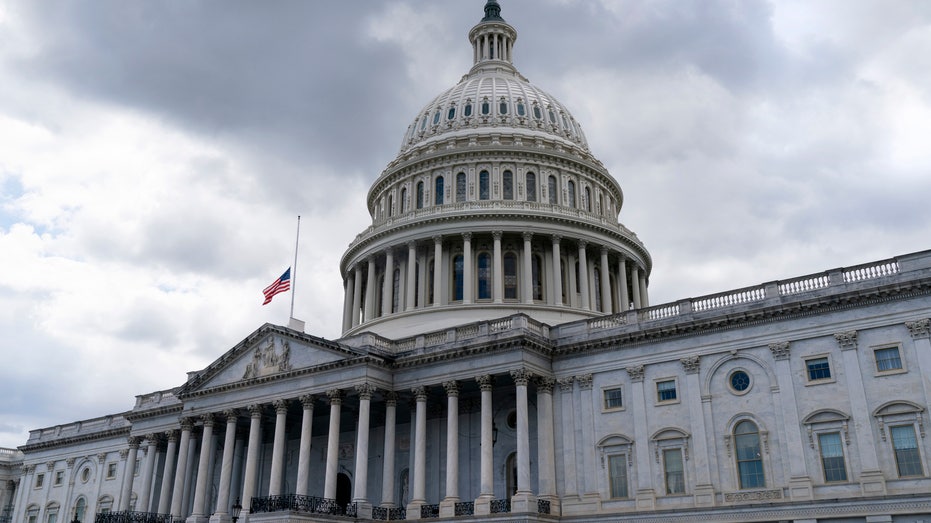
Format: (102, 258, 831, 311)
(680, 358, 716, 506)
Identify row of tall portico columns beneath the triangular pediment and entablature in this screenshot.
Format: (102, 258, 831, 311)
(117, 368, 557, 522)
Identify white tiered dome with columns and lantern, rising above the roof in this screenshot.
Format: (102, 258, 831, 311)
(340, 0, 652, 338)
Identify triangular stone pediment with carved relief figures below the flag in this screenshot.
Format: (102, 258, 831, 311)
(178, 324, 363, 397)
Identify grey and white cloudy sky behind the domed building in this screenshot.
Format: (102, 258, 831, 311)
(0, 0, 931, 447)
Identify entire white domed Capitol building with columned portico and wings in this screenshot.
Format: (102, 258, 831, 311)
(0, 4, 931, 523)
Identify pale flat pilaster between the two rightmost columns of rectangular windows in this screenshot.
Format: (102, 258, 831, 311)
(834, 331, 886, 496)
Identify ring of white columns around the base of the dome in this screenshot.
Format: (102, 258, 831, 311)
(343, 231, 649, 332)
